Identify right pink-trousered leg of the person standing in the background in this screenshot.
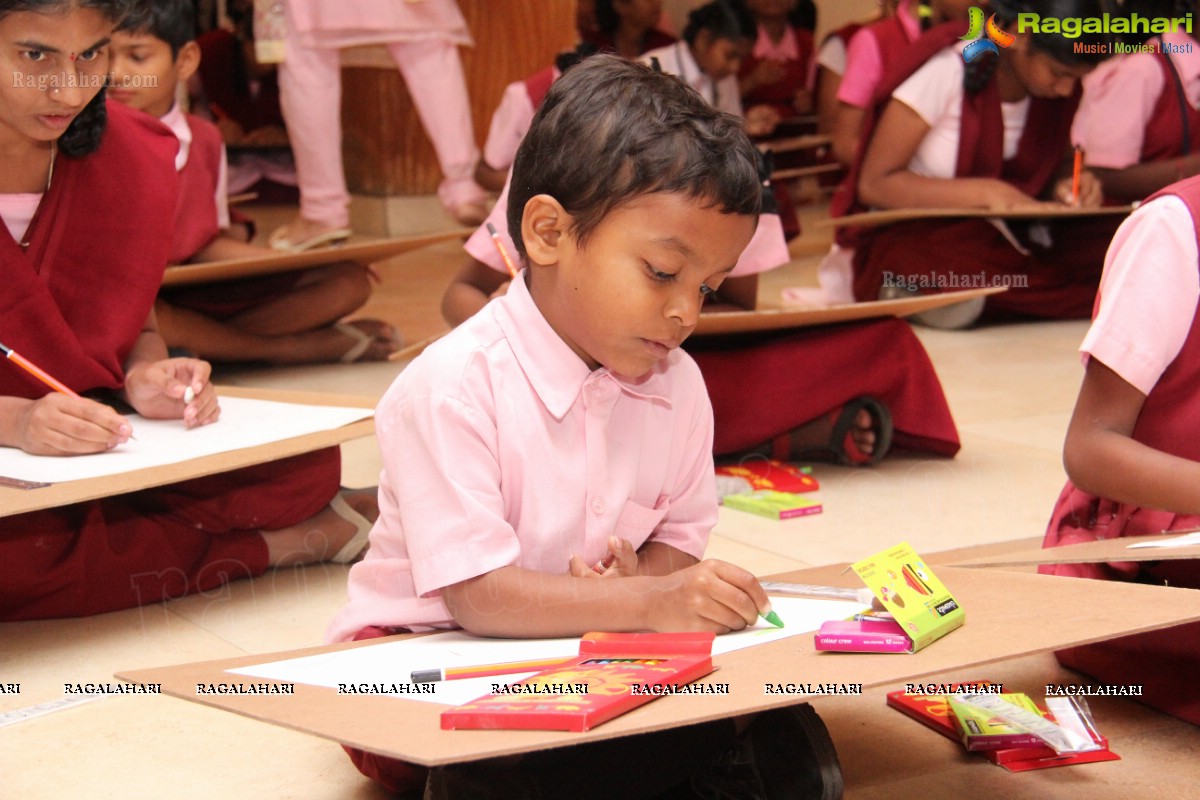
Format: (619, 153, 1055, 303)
(388, 40, 484, 222)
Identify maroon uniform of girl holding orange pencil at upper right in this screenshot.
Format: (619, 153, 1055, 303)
(834, 23, 1121, 319)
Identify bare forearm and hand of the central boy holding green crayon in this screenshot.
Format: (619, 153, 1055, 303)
(442, 561, 770, 638)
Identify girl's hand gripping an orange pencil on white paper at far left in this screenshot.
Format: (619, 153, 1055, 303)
(17, 392, 133, 456)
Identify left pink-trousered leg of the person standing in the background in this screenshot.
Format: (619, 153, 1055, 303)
(273, 21, 350, 229)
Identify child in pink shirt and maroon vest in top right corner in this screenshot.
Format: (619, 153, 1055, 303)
(1072, 0, 1200, 204)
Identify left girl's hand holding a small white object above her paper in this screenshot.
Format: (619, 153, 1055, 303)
(125, 359, 221, 428)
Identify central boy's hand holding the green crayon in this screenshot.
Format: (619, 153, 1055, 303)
(647, 559, 770, 633)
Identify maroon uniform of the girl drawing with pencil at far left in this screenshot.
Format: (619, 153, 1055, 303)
(0, 103, 340, 620)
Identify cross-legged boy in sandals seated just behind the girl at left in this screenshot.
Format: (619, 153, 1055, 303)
(112, 0, 398, 363)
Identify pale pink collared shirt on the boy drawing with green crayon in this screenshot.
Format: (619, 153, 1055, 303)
(326, 275, 716, 642)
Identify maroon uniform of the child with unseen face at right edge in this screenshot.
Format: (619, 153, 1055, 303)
(1038, 178, 1200, 724)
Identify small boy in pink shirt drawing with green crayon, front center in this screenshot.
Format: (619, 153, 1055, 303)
(326, 55, 832, 798)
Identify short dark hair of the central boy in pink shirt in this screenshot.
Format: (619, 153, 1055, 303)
(508, 55, 761, 266)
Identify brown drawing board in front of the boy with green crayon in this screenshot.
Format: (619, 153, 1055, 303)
(116, 565, 1200, 766)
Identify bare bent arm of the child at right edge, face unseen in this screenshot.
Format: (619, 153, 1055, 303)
(1063, 356, 1200, 513)
